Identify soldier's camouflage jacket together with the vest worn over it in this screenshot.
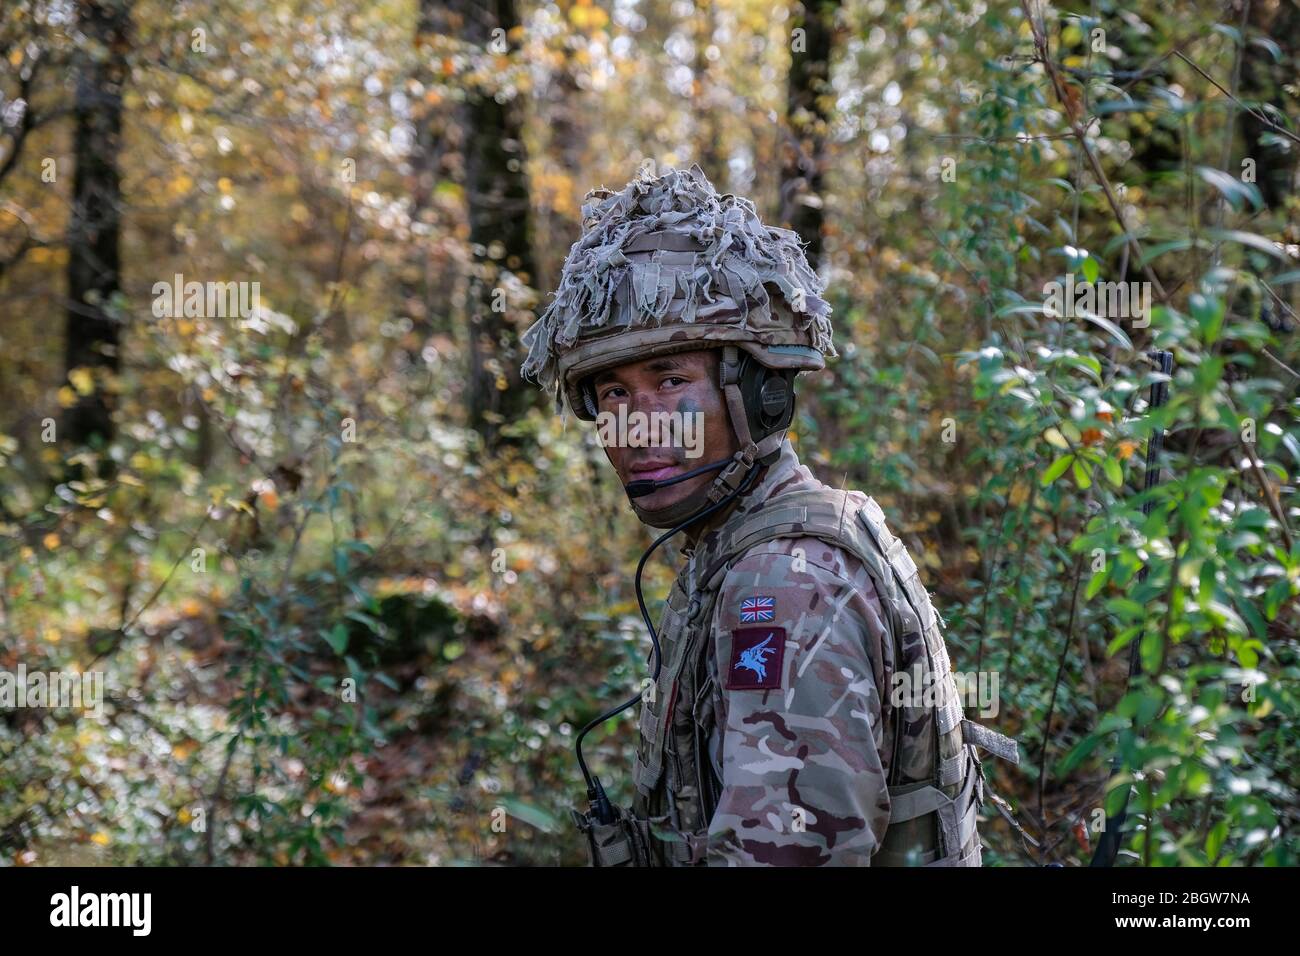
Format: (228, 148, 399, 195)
(629, 441, 1017, 866)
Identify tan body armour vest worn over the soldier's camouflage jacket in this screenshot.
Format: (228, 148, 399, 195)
(584, 484, 1018, 866)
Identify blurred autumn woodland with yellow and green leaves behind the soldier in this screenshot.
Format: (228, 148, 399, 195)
(0, 0, 1300, 865)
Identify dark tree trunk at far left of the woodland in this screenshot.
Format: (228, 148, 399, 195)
(64, 0, 131, 445)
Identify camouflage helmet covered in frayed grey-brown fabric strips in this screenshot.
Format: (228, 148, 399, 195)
(521, 165, 836, 420)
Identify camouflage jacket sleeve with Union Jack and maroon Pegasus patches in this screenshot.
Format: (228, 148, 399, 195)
(709, 542, 889, 866)
